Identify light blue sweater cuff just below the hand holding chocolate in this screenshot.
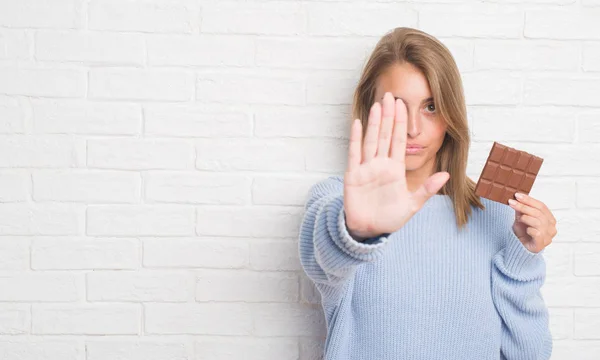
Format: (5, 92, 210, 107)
(504, 228, 546, 281)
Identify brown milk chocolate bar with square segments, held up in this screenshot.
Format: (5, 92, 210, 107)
(475, 141, 544, 205)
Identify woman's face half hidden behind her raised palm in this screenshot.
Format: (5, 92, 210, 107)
(375, 63, 446, 172)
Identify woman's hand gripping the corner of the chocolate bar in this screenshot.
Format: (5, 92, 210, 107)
(508, 193, 557, 253)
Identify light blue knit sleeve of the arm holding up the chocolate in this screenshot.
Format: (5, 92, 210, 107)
(492, 228, 552, 360)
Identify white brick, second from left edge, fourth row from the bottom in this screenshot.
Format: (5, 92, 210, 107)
(31, 237, 141, 270)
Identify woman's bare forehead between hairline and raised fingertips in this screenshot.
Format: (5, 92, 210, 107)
(375, 63, 431, 102)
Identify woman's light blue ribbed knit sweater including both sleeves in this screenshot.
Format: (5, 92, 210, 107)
(299, 176, 552, 360)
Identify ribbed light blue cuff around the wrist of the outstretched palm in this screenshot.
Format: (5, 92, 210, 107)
(326, 196, 390, 261)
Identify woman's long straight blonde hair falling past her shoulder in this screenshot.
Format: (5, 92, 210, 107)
(352, 27, 484, 228)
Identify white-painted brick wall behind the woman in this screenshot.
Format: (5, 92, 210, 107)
(0, 0, 600, 360)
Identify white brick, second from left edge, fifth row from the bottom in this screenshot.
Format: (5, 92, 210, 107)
(87, 205, 194, 236)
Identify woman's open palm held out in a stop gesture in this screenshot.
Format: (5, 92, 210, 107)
(344, 92, 450, 240)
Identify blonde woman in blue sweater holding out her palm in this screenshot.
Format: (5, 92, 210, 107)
(299, 28, 556, 360)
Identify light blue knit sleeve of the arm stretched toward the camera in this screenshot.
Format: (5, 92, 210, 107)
(298, 176, 390, 291)
